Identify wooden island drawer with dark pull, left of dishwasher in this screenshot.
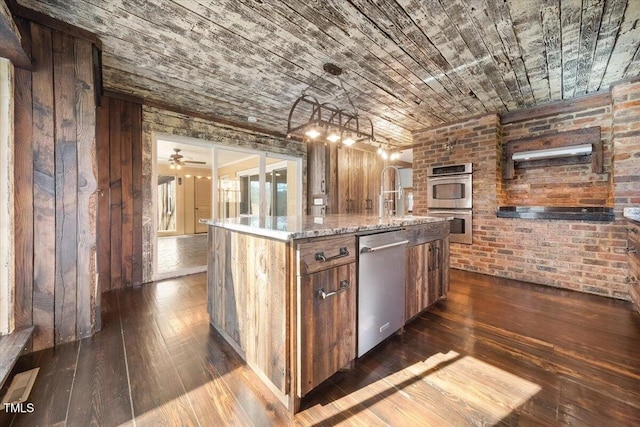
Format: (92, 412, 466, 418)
(297, 234, 356, 275)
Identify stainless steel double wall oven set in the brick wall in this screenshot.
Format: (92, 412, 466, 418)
(427, 163, 473, 245)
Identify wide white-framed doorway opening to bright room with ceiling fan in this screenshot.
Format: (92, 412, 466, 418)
(153, 135, 302, 280)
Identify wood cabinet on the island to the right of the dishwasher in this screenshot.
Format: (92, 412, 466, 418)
(405, 226, 449, 321)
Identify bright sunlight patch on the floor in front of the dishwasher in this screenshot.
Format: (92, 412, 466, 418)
(324, 351, 541, 425)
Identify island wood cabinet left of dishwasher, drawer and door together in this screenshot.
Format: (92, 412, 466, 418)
(295, 234, 357, 397)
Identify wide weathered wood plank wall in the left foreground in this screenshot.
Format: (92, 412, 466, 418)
(14, 21, 97, 350)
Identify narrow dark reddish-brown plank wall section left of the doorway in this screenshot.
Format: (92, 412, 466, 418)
(97, 96, 142, 292)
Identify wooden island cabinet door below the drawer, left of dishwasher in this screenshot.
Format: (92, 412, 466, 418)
(298, 263, 356, 396)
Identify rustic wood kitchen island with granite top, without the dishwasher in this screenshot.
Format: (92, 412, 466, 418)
(206, 215, 449, 413)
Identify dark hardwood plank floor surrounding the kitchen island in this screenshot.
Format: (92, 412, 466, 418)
(0, 270, 640, 427)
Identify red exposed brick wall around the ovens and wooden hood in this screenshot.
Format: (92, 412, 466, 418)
(413, 84, 640, 299)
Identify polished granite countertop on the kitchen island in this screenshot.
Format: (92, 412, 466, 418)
(200, 214, 451, 240)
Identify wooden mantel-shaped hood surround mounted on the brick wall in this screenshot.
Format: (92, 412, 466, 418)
(502, 126, 603, 179)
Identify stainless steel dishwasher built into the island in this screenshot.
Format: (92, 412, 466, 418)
(358, 230, 408, 357)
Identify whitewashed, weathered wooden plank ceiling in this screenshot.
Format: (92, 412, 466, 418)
(18, 0, 640, 145)
